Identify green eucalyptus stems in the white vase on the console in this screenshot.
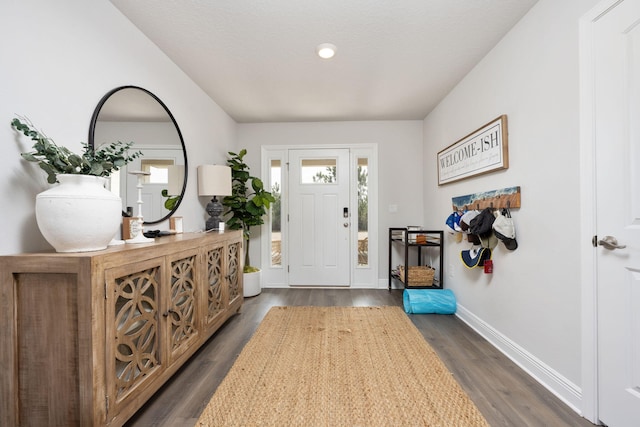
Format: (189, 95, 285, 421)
(11, 117, 142, 184)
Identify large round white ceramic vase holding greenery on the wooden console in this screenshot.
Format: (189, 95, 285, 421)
(36, 174, 122, 252)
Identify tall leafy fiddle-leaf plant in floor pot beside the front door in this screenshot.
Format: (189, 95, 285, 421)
(222, 149, 275, 273)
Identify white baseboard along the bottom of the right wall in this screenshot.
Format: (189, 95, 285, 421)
(456, 304, 582, 414)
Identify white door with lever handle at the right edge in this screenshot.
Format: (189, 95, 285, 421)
(593, 0, 640, 427)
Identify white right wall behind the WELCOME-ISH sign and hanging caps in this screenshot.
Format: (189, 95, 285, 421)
(424, 0, 596, 409)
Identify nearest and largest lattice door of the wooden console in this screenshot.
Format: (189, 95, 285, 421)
(105, 257, 166, 419)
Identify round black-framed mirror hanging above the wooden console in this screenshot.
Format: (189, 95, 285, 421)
(89, 86, 188, 224)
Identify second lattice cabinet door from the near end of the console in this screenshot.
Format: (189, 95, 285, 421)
(162, 248, 202, 362)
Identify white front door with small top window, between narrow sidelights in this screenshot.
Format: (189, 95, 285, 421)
(289, 149, 351, 286)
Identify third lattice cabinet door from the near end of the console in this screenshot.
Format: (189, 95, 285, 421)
(205, 243, 229, 328)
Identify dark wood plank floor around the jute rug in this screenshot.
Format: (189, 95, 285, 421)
(127, 289, 593, 427)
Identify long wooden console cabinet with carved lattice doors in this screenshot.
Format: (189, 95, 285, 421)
(0, 231, 243, 426)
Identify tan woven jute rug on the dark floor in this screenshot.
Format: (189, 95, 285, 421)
(196, 307, 488, 427)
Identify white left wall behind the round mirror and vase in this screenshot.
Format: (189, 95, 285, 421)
(0, 0, 236, 254)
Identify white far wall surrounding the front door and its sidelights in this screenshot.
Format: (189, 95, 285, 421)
(238, 120, 424, 278)
